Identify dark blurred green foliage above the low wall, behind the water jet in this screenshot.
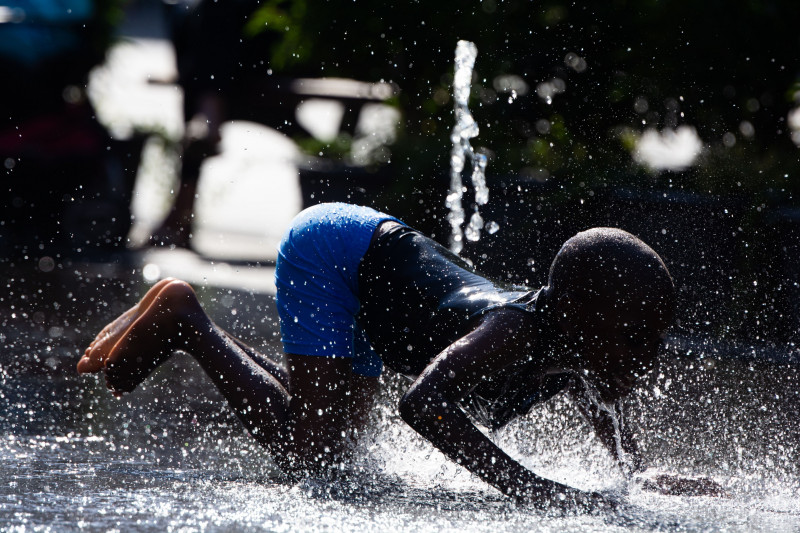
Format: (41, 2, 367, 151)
(252, 0, 800, 200)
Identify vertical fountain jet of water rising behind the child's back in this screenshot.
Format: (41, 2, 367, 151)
(445, 41, 497, 253)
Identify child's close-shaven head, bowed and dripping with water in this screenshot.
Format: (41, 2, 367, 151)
(549, 228, 675, 400)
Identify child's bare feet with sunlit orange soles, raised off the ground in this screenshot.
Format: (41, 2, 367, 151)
(78, 279, 196, 394)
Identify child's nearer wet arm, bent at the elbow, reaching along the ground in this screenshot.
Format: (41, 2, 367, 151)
(400, 311, 602, 504)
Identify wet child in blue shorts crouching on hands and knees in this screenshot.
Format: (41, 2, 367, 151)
(78, 204, 712, 504)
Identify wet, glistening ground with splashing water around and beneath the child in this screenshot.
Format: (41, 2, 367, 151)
(0, 259, 800, 531)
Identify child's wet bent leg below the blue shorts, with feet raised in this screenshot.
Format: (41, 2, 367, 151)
(78, 280, 350, 471)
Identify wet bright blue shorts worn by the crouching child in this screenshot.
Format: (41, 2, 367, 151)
(275, 203, 402, 376)
